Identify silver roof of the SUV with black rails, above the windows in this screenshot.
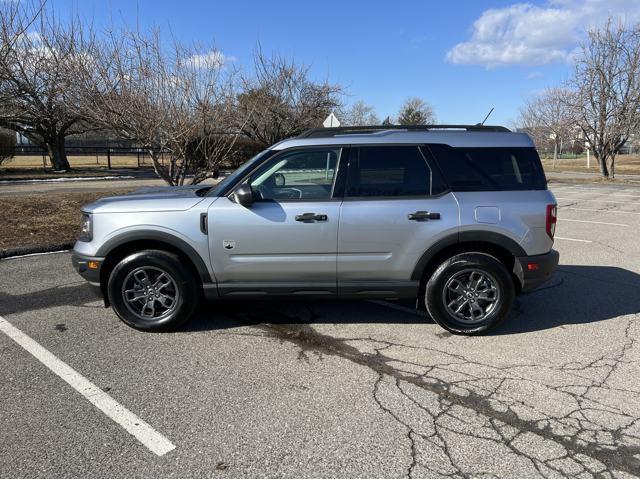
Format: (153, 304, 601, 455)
(271, 126, 534, 150)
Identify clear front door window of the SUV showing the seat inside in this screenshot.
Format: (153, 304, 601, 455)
(248, 148, 340, 200)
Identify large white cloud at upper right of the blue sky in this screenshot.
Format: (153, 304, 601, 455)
(446, 0, 640, 68)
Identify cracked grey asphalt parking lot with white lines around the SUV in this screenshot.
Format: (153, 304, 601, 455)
(0, 183, 640, 478)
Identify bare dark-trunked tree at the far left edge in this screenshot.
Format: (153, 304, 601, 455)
(0, 4, 87, 171)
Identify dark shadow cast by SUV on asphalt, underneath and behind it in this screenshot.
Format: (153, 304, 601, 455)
(181, 265, 640, 335)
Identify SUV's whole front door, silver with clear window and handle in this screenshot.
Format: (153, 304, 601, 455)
(208, 147, 341, 296)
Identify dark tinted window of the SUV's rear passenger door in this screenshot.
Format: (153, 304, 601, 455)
(345, 146, 444, 197)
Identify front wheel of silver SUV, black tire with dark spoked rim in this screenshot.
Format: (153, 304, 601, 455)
(107, 250, 200, 331)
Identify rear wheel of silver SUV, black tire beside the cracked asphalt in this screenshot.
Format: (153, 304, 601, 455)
(424, 253, 515, 335)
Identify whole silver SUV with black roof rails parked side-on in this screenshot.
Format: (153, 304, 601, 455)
(73, 125, 558, 334)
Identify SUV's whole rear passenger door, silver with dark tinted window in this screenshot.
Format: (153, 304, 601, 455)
(338, 145, 459, 297)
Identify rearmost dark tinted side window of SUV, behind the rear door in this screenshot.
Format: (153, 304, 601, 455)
(429, 144, 547, 191)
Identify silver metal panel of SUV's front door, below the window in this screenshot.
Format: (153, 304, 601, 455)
(209, 198, 340, 285)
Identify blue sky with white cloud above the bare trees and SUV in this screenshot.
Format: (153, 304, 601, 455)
(50, 0, 640, 125)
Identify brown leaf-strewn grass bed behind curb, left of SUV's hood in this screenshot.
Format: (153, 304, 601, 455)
(0, 189, 132, 250)
